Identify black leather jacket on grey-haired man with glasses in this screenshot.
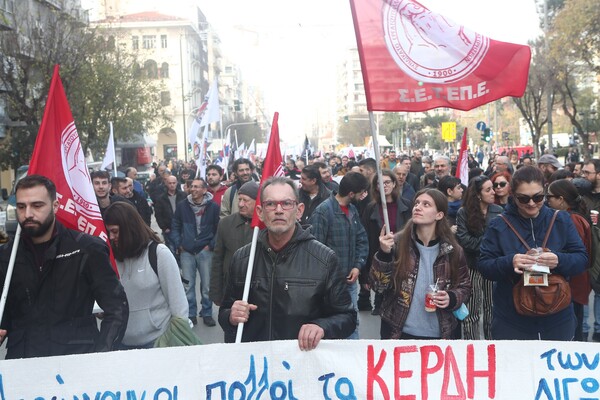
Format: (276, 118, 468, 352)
(219, 223, 356, 342)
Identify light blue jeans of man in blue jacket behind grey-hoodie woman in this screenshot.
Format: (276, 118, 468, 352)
(180, 250, 213, 318)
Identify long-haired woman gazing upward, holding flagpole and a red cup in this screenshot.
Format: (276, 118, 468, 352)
(371, 189, 471, 339)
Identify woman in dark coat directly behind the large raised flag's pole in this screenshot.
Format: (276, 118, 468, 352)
(363, 169, 412, 315)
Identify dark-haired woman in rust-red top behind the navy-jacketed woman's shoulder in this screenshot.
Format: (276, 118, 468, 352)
(546, 179, 592, 342)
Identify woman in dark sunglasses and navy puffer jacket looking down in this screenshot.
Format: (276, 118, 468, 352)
(478, 167, 588, 340)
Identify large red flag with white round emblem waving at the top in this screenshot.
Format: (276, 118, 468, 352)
(350, 0, 531, 111)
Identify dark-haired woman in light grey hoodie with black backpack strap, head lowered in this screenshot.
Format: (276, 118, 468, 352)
(104, 201, 188, 349)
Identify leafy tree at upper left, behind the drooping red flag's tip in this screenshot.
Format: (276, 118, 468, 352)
(0, 2, 168, 168)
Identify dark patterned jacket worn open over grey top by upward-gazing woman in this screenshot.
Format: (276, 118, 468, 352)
(371, 229, 471, 339)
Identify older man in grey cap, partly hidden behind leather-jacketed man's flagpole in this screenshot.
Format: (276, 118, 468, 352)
(209, 181, 258, 312)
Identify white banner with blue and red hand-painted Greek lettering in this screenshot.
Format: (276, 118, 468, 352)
(0, 340, 600, 400)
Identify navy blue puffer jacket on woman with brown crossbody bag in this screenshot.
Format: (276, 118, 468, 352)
(477, 200, 588, 332)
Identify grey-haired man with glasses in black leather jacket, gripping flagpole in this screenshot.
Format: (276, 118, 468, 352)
(219, 177, 356, 350)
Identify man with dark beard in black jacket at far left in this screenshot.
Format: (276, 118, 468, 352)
(0, 175, 129, 359)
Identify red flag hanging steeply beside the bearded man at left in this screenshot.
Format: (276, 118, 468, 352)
(28, 65, 116, 272)
